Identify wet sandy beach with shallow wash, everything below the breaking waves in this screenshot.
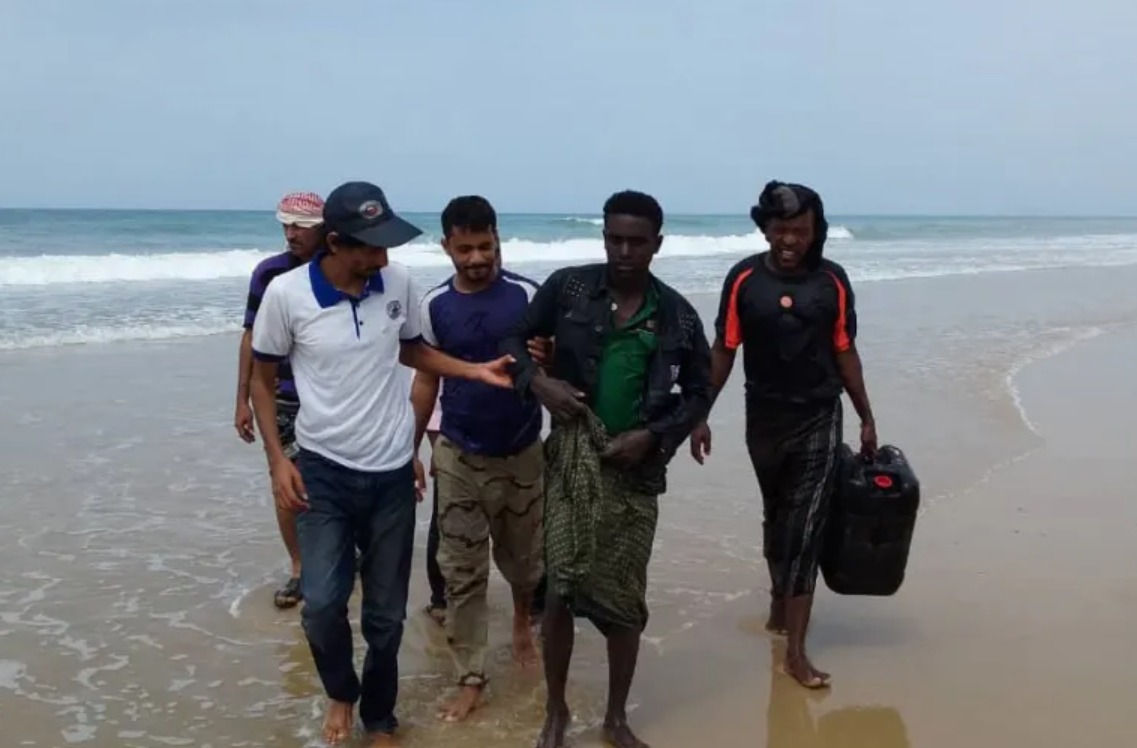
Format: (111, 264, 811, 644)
(0, 268, 1137, 748)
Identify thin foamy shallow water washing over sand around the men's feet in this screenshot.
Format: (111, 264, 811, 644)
(0, 268, 1137, 748)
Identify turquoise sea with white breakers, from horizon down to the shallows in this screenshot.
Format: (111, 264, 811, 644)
(0, 209, 1137, 349)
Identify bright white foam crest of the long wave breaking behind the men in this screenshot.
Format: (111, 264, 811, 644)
(0, 226, 853, 285)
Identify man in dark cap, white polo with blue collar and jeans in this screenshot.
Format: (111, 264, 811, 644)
(252, 182, 511, 747)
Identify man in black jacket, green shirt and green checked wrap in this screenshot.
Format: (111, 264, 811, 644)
(501, 191, 712, 748)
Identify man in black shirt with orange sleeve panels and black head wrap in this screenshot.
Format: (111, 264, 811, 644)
(691, 182, 877, 688)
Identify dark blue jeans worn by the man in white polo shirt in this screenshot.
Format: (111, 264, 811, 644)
(297, 450, 415, 733)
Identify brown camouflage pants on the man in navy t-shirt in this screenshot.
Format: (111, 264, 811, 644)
(434, 437, 545, 685)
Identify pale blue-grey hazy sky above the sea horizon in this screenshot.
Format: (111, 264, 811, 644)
(0, 0, 1137, 215)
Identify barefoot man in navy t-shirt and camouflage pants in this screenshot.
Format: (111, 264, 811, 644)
(412, 196, 545, 721)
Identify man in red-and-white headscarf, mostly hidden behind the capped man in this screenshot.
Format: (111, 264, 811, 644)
(233, 192, 324, 609)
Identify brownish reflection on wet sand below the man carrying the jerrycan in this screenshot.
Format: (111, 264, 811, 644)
(765, 641, 910, 748)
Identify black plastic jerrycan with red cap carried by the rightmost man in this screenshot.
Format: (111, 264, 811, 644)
(821, 444, 920, 596)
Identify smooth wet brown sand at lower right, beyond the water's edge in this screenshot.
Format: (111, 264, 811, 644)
(600, 329, 1137, 748)
